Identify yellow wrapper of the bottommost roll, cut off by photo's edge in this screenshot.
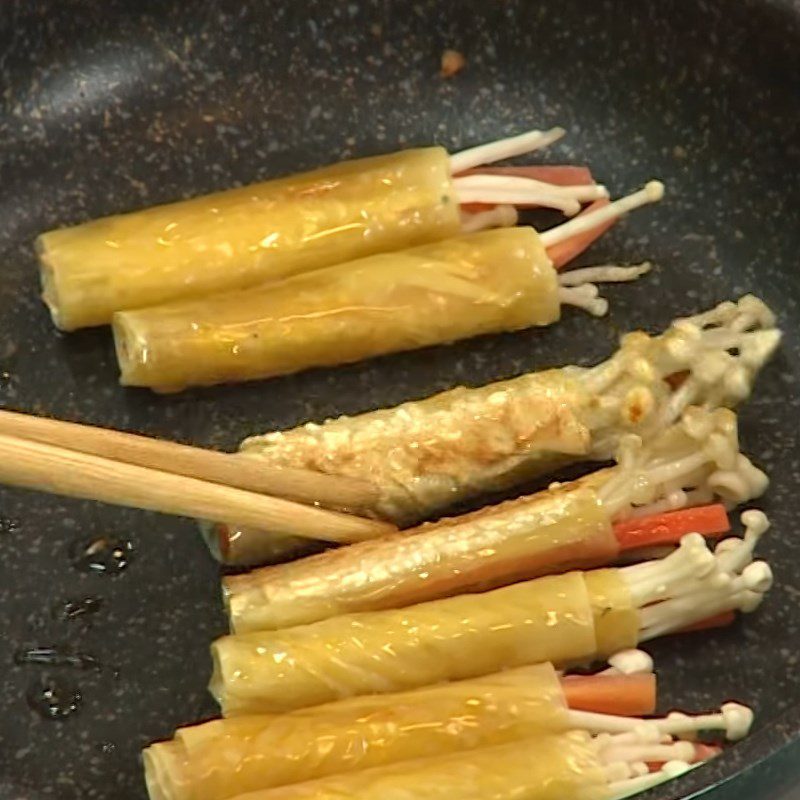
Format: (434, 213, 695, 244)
(203, 732, 610, 800)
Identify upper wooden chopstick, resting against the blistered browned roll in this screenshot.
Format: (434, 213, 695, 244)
(0, 411, 379, 513)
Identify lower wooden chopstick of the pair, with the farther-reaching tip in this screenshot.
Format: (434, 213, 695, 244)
(0, 434, 396, 543)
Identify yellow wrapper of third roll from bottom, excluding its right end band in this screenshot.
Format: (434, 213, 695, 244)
(209, 572, 597, 716)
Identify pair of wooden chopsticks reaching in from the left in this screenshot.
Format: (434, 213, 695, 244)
(0, 411, 396, 543)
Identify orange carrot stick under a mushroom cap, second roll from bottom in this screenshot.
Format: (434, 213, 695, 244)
(561, 673, 657, 717)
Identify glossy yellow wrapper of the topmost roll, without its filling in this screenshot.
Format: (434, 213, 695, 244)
(36, 147, 460, 330)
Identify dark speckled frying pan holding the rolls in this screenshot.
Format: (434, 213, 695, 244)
(0, 0, 800, 800)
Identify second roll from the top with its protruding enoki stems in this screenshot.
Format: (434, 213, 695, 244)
(113, 181, 663, 392)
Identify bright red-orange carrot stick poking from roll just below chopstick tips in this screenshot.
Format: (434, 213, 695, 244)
(614, 503, 731, 550)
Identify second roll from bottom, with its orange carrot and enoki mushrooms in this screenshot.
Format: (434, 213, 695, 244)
(152, 650, 753, 800)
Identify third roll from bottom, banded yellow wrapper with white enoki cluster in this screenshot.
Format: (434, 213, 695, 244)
(209, 511, 772, 716)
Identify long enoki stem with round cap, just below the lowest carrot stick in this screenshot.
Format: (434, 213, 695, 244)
(567, 703, 754, 740)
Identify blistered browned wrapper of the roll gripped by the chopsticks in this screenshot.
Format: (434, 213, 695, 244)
(242, 369, 592, 525)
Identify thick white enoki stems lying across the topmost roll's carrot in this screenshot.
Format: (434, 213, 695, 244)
(453, 175, 608, 217)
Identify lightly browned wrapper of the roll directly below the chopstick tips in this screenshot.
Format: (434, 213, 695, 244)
(224, 481, 619, 633)
